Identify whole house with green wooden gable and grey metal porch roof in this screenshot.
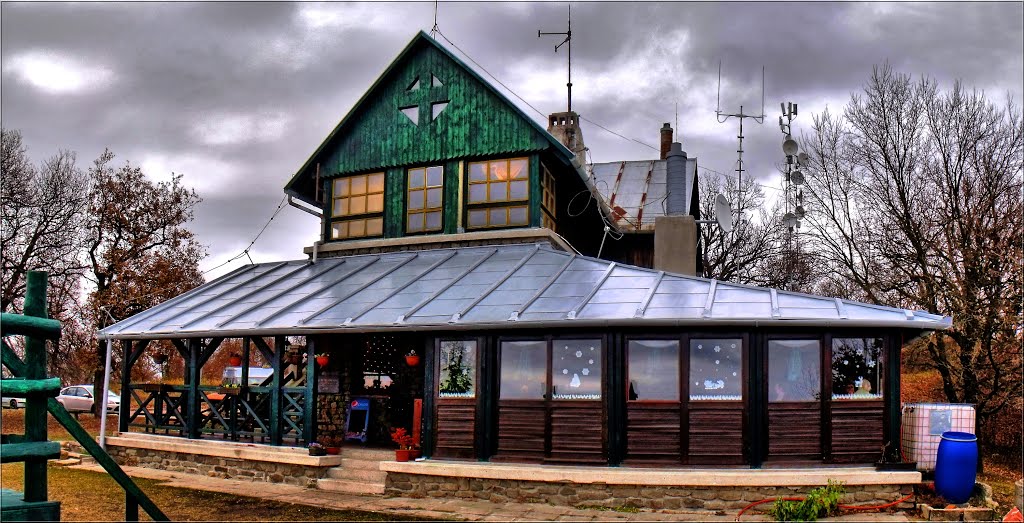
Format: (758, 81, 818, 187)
(99, 32, 951, 507)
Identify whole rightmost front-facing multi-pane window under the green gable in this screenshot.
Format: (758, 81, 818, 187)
(466, 158, 529, 228)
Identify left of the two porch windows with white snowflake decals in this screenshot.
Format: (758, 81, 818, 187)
(551, 340, 601, 399)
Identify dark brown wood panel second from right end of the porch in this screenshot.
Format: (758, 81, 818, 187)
(768, 401, 821, 461)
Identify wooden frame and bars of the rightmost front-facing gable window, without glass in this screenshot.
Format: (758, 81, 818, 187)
(464, 157, 530, 230)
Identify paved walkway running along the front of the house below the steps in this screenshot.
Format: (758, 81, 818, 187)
(72, 464, 910, 522)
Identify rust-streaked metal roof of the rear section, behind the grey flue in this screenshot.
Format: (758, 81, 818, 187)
(590, 158, 697, 231)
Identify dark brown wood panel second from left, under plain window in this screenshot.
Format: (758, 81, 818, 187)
(492, 399, 547, 463)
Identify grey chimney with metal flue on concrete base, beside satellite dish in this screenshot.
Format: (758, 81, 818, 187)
(654, 141, 697, 276)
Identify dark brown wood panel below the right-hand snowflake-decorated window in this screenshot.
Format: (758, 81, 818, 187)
(688, 401, 744, 465)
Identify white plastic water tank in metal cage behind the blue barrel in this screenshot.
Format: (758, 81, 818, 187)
(900, 403, 975, 471)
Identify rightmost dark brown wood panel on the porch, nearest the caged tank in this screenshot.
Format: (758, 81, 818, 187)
(831, 400, 885, 463)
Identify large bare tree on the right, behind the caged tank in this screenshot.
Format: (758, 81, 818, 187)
(804, 64, 1024, 433)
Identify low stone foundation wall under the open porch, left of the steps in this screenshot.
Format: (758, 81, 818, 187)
(106, 445, 328, 487)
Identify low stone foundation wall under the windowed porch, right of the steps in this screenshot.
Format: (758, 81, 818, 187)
(384, 472, 913, 511)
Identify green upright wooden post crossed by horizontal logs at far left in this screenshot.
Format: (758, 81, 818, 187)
(25, 271, 47, 503)
